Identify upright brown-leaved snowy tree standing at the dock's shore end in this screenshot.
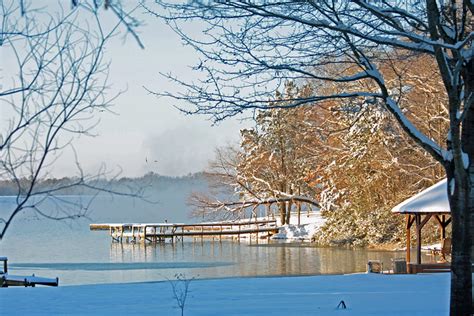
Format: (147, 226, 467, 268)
(237, 82, 315, 224)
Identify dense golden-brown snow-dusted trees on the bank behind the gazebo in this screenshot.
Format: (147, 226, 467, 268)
(313, 56, 448, 245)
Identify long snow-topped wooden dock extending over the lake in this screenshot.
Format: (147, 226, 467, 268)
(90, 220, 278, 243)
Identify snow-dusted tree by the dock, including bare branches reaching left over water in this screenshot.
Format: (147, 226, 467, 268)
(191, 82, 318, 225)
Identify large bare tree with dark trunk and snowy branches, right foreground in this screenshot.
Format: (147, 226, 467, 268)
(147, 0, 474, 315)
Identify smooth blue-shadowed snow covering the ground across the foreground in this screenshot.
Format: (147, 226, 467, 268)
(0, 273, 450, 316)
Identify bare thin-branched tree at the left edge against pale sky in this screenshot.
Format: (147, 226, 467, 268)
(0, 0, 140, 241)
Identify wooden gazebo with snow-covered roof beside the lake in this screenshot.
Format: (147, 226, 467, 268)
(392, 179, 451, 273)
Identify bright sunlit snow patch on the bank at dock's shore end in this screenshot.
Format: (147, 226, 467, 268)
(271, 211, 325, 241)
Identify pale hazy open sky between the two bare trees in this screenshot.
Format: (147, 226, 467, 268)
(9, 3, 249, 177)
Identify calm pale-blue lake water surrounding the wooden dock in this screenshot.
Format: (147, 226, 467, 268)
(0, 195, 414, 285)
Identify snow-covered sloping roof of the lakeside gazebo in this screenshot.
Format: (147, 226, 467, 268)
(392, 179, 451, 213)
